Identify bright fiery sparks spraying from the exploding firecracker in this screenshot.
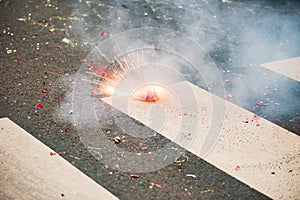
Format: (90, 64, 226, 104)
(81, 45, 159, 102)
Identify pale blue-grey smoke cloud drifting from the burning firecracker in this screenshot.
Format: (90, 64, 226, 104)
(54, 0, 300, 172)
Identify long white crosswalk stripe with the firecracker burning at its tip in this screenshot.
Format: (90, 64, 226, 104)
(102, 82, 300, 199)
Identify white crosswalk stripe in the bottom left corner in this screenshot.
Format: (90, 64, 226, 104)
(0, 118, 117, 200)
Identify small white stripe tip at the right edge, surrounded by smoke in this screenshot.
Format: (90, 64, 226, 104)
(261, 57, 300, 81)
